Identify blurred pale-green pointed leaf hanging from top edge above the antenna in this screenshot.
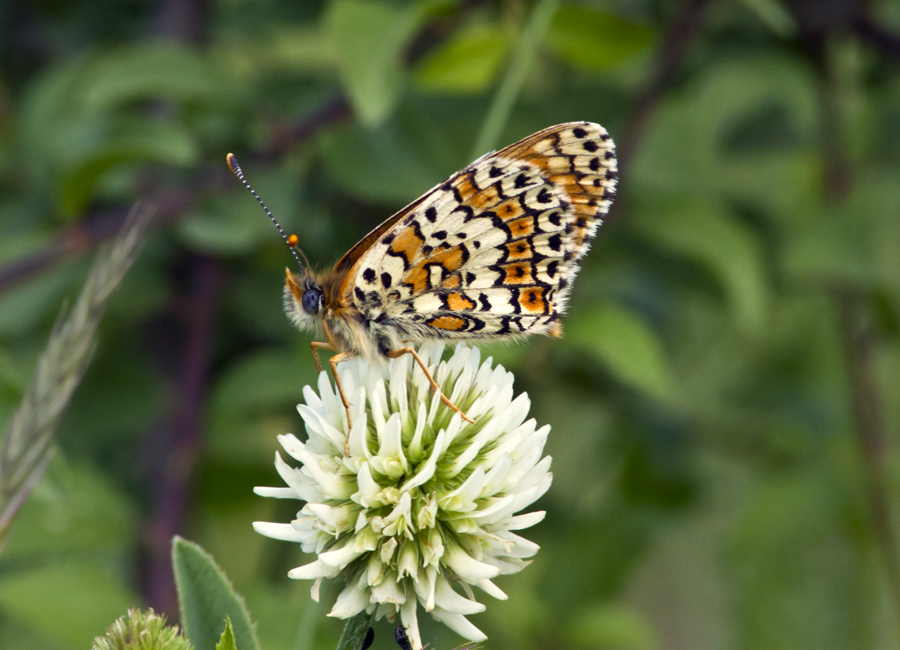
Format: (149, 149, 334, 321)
(324, 0, 421, 126)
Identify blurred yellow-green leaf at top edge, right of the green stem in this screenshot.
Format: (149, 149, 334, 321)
(545, 5, 654, 70)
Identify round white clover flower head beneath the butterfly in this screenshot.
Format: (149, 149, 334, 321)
(253, 344, 551, 650)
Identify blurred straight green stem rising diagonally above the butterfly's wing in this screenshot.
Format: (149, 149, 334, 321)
(470, 0, 559, 160)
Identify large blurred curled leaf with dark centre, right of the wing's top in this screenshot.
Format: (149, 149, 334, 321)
(629, 54, 821, 215)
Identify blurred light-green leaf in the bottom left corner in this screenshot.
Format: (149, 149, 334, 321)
(0, 562, 140, 650)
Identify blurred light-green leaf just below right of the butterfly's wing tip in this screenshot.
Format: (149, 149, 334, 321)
(564, 305, 674, 399)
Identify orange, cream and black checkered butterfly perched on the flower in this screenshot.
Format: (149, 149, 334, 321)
(227, 122, 618, 436)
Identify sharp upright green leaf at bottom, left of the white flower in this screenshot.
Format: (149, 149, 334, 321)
(172, 537, 259, 650)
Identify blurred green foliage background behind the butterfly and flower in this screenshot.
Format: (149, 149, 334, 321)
(0, 0, 900, 650)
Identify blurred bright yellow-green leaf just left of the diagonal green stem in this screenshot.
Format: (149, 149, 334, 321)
(415, 24, 509, 93)
